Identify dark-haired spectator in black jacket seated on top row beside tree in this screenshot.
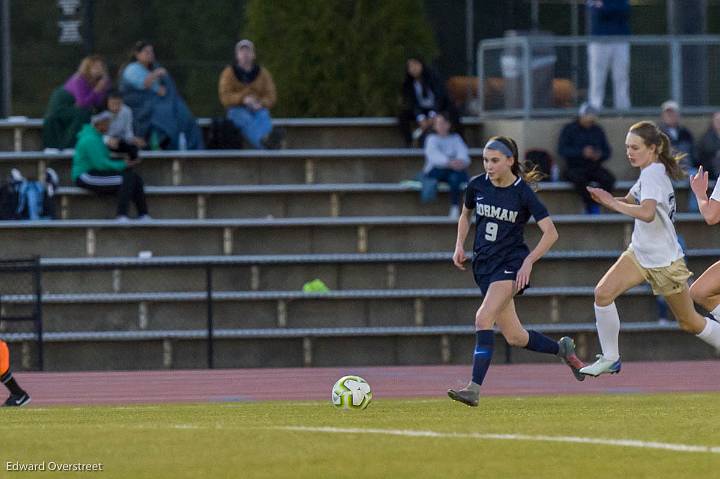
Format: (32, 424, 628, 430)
(398, 57, 462, 147)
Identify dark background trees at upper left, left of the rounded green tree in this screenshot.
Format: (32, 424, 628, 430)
(11, 0, 245, 117)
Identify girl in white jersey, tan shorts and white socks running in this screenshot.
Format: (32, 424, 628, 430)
(580, 121, 720, 376)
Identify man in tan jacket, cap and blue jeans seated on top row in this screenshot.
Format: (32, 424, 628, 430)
(218, 40, 282, 149)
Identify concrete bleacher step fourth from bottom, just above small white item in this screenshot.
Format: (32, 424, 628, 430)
(0, 214, 720, 257)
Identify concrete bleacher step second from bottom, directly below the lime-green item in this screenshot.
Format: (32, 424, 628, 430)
(3, 286, 658, 333)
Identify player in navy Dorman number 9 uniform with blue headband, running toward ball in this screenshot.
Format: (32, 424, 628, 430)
(448, 136, 585, 406)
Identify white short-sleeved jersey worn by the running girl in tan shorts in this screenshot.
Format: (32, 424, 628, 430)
(630, 163, 683, 268)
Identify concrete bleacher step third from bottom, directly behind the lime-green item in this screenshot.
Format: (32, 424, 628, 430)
(19, 250, 720, 295)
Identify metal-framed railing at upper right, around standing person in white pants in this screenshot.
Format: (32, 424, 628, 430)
(477, 34, 720, 118)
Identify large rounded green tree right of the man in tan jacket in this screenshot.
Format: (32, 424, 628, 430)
(243, 0, 437, 117)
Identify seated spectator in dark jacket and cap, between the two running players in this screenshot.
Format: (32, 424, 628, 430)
(558, 103, 615, 214)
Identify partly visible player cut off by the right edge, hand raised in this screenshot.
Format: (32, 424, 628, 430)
(690, 166, 720, 330)
